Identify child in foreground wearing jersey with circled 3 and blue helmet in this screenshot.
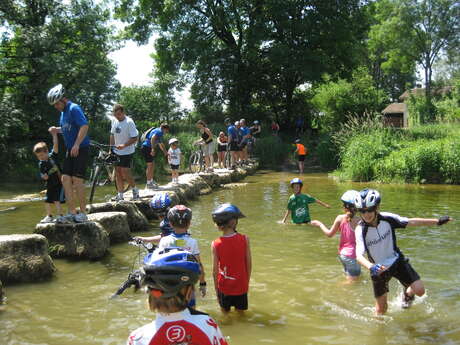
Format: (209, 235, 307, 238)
(127, 248, 227, 345)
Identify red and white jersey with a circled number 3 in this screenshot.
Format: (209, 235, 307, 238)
(127, 309, 228, 345)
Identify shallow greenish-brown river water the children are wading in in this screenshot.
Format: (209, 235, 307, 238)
(0, 172, 460, 345)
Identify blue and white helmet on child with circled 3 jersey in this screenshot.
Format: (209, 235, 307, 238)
(141, 247, 201, 298)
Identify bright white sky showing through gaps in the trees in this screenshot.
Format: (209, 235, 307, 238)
(109, 38, 193, 109)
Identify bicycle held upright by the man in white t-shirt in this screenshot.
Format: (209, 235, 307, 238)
(89, 141, 129, 204)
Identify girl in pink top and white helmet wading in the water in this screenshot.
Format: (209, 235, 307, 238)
(311, 190, 361, 282)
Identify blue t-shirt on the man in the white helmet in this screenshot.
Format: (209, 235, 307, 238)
(59, 101, 89, 150)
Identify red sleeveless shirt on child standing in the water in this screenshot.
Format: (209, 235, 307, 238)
(212, 233, 249, 296)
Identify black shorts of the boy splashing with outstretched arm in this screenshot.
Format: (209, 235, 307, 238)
(371, 258, 420, 298)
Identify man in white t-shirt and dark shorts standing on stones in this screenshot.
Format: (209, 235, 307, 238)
(110, 104, 139, 201)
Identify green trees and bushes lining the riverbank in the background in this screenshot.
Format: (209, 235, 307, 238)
(0, 0, 460, 183)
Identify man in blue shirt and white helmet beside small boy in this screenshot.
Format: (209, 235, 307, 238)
(47, 84, 89, 223)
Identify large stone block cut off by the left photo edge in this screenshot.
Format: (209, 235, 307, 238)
(0, 235, 55, 282)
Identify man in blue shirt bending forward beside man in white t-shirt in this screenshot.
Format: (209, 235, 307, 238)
(141, 123, 169, 189)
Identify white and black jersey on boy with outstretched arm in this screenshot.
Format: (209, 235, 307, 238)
(355, 212, 409, 267)
